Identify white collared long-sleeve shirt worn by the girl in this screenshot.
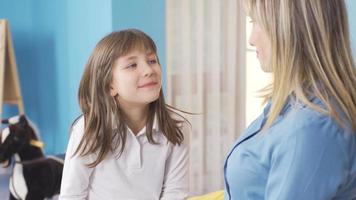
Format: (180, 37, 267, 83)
(59, 117, 190, 200)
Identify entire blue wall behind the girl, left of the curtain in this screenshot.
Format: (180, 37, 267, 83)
(0, 0, 165, 154)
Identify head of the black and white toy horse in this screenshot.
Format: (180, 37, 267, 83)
(0, 115, 44, 166)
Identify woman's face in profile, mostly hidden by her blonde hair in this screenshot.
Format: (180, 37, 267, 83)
(249, 21, 272, 72)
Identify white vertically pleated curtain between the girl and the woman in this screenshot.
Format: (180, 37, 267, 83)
(166, 0, 246, 195)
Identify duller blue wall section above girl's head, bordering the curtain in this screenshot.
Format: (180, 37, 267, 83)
(112, 0, 166, 91)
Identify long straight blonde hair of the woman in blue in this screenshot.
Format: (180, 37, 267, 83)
(243, 0, 356, 130)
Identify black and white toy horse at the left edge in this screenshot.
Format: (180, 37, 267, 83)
(0, 115, 64, 200)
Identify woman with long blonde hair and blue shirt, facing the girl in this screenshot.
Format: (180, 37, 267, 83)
(224, 0, 356, 200)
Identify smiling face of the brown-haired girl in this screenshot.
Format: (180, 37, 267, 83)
(110, 50, 161, 108)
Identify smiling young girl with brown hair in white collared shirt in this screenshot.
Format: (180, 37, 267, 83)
(59, 29, 190, 200)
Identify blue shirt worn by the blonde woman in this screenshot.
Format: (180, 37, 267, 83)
(224, 98, 356, 200)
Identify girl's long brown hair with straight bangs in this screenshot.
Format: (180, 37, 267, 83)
(74, 29, 185, 167)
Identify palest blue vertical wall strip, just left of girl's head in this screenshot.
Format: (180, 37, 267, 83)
(61, 0, 112, 154)
